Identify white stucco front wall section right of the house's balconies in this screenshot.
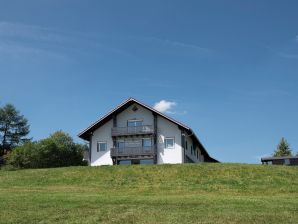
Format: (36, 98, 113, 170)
(157, 116, 182, 164)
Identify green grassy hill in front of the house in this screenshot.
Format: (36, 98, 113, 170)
(0, 164, 298, 224)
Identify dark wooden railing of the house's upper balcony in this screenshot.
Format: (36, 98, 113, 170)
(112, 125, 154, 136)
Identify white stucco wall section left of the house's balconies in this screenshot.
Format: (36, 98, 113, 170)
(91, 119, 113, 166)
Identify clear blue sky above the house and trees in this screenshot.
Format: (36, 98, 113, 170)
(0, 0, 298, 163)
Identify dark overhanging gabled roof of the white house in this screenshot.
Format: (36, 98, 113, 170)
(78, 97, 218, 162)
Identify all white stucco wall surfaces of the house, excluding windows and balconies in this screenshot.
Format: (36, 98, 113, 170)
(91, 105, 190, 166)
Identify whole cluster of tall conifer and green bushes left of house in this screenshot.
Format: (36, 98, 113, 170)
(0, 104, 88, 168)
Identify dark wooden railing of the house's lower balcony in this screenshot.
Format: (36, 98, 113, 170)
(111, 146, 154, 157)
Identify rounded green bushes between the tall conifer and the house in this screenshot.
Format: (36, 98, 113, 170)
(8, 131, 85, 168)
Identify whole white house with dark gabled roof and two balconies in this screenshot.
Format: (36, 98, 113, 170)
(79, 98, 218, 166)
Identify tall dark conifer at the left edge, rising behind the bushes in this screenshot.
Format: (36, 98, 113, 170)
(0, 104, 29, 156)
